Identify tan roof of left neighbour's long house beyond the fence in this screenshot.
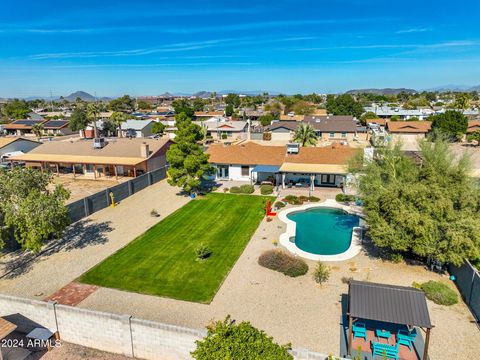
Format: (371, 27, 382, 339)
(11, 138, 171, 165)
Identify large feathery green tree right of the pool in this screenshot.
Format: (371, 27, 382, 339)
(350, 139, 480, 265)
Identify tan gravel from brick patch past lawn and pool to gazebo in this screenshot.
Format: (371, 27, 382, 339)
(79, 210, 480, 359)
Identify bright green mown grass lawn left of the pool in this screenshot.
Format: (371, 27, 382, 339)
(80, 194, 267, 303)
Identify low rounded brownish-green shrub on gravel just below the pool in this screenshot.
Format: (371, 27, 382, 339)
(258, 250, 308, 277)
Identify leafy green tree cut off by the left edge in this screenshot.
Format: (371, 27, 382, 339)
(0, 168, 69, 252)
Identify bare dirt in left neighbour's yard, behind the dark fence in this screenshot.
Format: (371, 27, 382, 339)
(53, 175, 126, 204)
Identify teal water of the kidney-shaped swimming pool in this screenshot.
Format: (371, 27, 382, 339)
(287, 208, 359, 255)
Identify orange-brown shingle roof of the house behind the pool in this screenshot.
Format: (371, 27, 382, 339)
(207, 142, 357, 166)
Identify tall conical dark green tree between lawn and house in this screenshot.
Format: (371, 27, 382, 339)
(167, 113, 213, 193)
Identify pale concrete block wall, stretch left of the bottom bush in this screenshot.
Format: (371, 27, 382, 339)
(0, 295, 206, 359)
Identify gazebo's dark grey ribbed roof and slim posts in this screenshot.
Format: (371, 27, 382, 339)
(347, 280, 433, 360)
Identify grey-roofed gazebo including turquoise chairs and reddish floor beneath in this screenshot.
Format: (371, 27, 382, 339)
(340, 280, 433, 360)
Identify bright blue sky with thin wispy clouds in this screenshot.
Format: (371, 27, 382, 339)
(0, 0, 480, 97)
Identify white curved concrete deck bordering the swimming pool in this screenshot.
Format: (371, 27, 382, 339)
(278, 199, 362, 261)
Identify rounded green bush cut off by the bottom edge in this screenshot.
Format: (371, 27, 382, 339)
(191, 316, 293, 360)
